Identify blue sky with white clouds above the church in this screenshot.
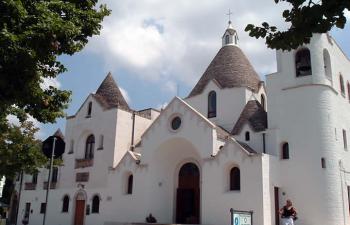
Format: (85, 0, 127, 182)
(36, 0, 350, 139)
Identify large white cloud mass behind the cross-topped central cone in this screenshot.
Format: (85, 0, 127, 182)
(87, 0, 285, 89)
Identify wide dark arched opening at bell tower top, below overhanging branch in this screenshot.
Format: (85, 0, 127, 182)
(295, 48, 312, 77)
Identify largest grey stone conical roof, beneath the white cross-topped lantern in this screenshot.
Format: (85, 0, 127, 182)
(188, 45, 260, 97)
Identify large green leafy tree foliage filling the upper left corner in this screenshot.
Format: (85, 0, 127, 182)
(0, 0, 110, 123)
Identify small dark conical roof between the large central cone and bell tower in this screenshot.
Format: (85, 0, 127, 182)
(231, 100, 267, 135)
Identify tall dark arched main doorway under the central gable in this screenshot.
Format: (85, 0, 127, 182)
(176, 163, 200, 224)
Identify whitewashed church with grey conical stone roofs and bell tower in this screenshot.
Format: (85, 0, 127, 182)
(10, 20, 350, 225)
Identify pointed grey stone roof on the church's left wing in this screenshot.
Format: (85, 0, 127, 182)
(93, 73, 130, 110)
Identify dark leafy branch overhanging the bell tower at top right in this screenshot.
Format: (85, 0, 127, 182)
(245, 0, 350, 50)
